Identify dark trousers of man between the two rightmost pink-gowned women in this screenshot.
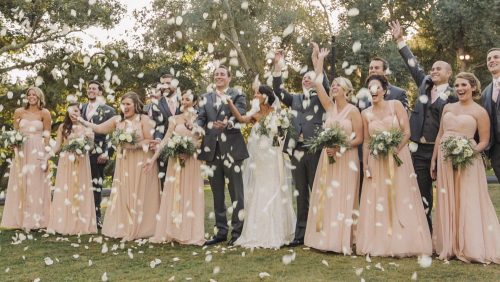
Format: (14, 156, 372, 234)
(411, 143, 434, 233)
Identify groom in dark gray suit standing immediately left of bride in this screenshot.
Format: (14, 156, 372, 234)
(196, 65, 248, 245)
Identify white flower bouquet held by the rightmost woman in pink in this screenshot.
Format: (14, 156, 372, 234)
(441, 136, 478, 170)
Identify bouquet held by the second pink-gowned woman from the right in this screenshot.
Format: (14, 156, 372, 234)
(369, 128, 403, 166)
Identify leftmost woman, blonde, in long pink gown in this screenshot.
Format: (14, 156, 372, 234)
(0, 87, 52, 231)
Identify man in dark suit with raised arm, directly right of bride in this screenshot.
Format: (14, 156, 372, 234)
(273, 47, 330, 247)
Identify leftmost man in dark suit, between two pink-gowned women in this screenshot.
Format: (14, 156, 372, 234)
(81, 80, 116, 229)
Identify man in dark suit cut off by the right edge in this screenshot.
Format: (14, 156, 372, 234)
(481, 48, 500, 180)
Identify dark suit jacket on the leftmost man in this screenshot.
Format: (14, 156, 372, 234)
(80, 103, 116, 157)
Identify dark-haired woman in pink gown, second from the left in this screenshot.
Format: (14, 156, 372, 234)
(47, 103, 97, 235)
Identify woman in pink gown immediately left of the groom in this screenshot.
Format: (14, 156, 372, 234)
(144, 91, 205, 246)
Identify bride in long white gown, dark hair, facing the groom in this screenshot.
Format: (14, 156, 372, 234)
(228, 85, 296, 248)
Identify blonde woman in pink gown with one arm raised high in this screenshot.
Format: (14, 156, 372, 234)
(304, 45, 363, 255)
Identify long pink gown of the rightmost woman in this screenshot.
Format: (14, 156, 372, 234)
(432, 112, 500, 263)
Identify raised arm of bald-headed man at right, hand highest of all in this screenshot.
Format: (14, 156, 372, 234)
(389, 21, 425, 86)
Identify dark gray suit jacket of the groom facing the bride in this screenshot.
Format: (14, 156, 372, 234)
(196, 88, 248, 162)
